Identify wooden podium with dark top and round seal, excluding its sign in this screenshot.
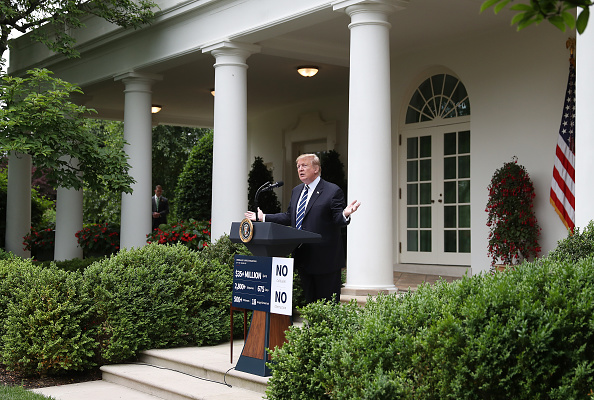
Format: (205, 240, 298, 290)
(229, 222, 322, 376)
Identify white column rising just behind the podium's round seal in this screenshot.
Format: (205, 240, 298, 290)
(203, 42, 260, 240)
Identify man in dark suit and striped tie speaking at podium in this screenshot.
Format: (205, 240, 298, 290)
(245, 154, 361, 303)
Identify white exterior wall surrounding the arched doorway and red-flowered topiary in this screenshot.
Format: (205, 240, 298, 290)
(392, 24, 569, 274)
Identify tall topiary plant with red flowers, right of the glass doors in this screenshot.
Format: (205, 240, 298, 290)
(485, 157, 541, 268)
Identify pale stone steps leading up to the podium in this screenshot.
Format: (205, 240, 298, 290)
(34, 340, 269, 400)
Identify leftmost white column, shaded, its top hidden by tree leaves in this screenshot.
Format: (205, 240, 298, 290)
(5, 153, 31, 258)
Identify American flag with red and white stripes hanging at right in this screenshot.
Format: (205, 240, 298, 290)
(550, 58, 575, 232)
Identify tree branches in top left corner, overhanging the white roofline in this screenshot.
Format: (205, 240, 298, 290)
(0, 0, 156, 58)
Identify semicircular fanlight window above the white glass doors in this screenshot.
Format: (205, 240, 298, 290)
(406, 74, 470, 124)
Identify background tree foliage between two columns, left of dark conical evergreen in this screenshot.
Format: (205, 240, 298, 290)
(152, 125, 210, 211)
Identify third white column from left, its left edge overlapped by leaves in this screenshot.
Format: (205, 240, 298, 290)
(115, 72, 160, 249)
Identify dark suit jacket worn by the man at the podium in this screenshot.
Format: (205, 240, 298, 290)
(266, 179, 348, 274)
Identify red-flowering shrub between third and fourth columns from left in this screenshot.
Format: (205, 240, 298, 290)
(146, 219, 210, 250)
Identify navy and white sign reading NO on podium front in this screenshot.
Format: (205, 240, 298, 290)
(233, 255, 293, 315)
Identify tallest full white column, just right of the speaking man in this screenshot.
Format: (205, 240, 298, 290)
(334, 0, 396, 294)
